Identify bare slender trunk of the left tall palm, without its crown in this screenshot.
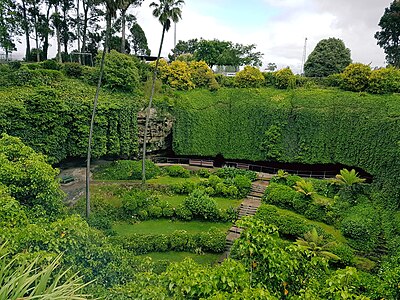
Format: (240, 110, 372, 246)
(86, 12, 111, 218)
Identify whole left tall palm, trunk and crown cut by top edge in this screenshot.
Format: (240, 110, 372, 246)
(86, 0, 119, 218)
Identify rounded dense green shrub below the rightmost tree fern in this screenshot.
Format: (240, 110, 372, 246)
(340, 204, 381, 253)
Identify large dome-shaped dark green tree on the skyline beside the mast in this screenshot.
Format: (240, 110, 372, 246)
(304, 38, 351, 77)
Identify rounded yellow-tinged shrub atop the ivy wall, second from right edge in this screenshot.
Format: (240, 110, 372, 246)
(342, 63, 371, 92)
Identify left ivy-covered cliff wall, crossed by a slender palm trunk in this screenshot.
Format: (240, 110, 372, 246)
(0, 80, 141, 163)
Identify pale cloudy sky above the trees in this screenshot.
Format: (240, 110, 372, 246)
(16, 0, 392, 73)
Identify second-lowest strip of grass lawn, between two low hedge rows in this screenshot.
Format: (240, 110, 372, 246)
(113, 219, 232, 236)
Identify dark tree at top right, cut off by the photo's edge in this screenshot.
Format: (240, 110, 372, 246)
(375, 0, 400, 68)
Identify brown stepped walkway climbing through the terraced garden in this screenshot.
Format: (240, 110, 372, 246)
(218, 176, 270, 263)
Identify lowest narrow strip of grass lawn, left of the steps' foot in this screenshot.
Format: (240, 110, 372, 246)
(139, 251, 221, 265)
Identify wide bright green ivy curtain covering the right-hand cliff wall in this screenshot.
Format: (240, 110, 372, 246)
(173, 89, 400, 206)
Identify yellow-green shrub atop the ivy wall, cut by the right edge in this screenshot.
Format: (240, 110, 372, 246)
(368, 67, 400, 94)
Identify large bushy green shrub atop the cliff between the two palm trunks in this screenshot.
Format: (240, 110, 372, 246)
(101, 50, 139, 92)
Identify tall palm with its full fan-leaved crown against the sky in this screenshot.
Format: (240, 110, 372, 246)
(142, 0, 185, 186)
